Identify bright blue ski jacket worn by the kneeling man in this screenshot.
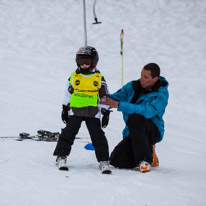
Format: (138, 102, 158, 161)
(109, 76, 169, 142)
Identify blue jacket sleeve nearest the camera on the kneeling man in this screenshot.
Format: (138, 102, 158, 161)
(118, 96, 167, 119)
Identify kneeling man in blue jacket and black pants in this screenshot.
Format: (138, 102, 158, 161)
(101, 63, 169, 172)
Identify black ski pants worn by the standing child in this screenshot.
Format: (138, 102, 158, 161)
(53, 116, 109, 162)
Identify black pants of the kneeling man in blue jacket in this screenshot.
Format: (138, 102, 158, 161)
(110, 114, 160, 168)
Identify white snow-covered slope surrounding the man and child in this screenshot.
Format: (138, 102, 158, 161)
(0, 0, 206, 206)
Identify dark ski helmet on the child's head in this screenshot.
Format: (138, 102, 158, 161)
(76, 46, 99, 68)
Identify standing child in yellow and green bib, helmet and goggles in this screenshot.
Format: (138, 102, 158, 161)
(53, 46, 111, 174)
